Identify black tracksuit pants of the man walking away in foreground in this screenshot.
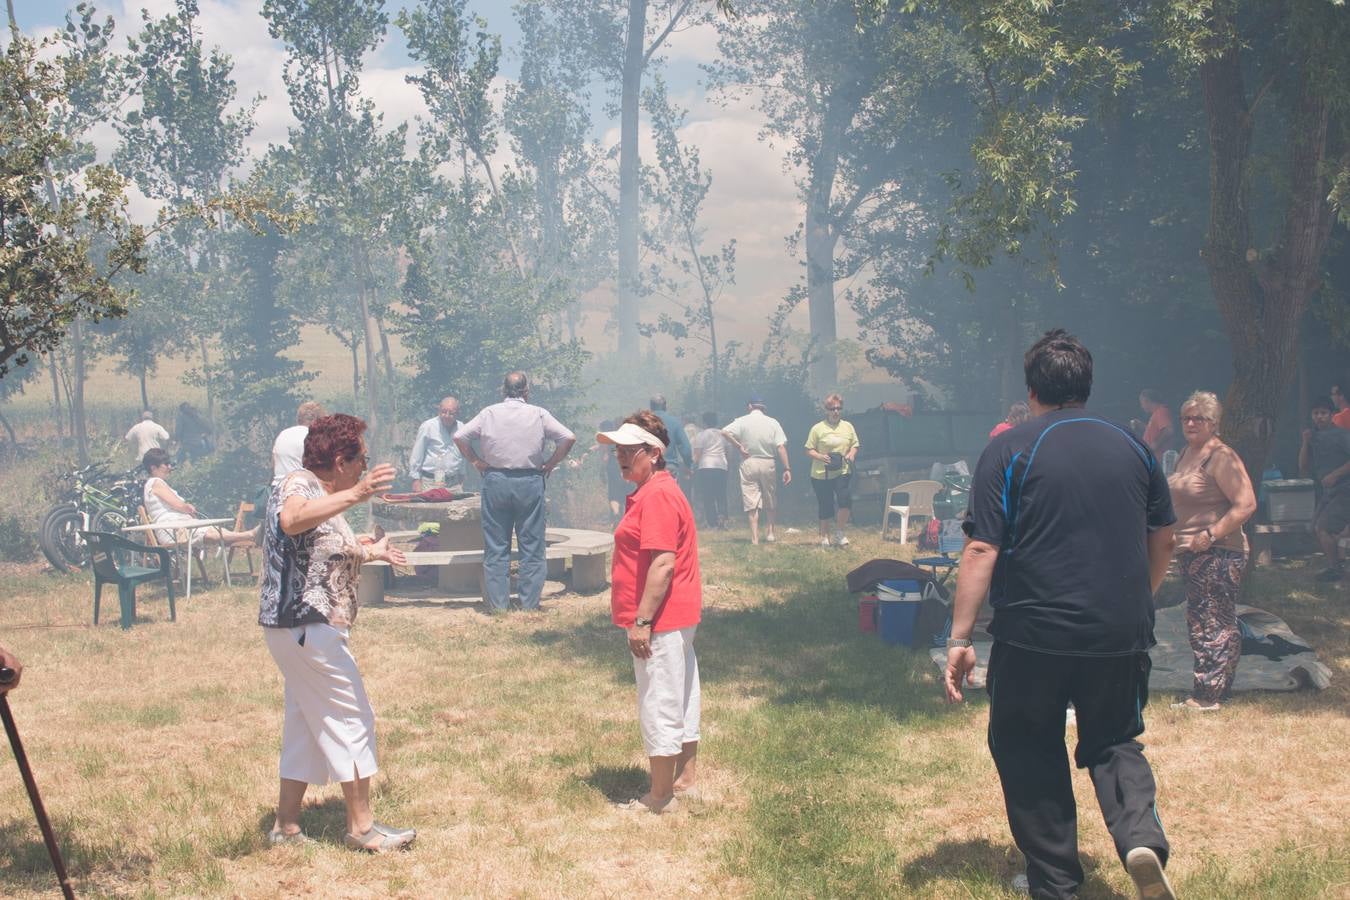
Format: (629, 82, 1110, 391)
(987, 642, 1168, 900)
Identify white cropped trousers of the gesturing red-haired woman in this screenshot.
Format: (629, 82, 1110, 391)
(263, 625, 378, 784)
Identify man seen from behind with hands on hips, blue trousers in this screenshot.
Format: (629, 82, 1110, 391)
(455, 372, 576, 613)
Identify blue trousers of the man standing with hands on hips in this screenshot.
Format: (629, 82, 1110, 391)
(482, 470, 547, 613)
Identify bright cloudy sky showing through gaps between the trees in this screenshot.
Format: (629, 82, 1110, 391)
(16, 0, 880, 369)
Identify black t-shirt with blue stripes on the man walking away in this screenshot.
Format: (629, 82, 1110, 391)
(965, 409, 1176, 656)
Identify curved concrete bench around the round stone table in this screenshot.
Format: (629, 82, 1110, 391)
(356, 528, 614, 604)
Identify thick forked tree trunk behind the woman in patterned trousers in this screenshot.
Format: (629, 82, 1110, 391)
(1200, 28, 1331, 483)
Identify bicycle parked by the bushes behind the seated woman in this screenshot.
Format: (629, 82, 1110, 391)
(38, 463, 143, 572)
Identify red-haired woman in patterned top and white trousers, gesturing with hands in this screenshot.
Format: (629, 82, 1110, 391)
(258, 414, 417, 853)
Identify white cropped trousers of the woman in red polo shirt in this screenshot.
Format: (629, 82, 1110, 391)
(633, 625, 701, 756)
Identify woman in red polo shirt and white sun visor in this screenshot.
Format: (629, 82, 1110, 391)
(595, 409, 703, 812)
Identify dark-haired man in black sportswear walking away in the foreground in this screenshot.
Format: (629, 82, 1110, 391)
(944, 331, 1176, 899)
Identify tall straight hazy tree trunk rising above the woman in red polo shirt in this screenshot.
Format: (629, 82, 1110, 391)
(616, 0, 647, 360)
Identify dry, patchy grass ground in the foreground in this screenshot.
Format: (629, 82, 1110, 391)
(0, 529, 1350, 900)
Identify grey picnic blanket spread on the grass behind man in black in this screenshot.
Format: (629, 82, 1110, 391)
(930, 603, 1331, 691)
